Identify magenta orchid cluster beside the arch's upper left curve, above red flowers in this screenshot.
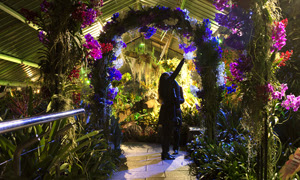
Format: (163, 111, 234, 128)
(82, 34, 102, 60)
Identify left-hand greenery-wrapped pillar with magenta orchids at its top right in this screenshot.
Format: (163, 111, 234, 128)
(21, 0, 101, 112)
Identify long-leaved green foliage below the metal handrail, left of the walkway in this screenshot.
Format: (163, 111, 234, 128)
(0, 120, 120, 179)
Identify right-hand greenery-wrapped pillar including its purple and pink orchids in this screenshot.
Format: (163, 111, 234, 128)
(215, 0, 287, 179)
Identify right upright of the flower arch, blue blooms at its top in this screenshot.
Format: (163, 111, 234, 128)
(194, 19, 222, 141)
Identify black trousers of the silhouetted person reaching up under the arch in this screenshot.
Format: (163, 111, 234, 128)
(161, 123, 180, 154)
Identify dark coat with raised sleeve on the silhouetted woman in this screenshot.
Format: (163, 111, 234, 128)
(158, 60, 184, 125)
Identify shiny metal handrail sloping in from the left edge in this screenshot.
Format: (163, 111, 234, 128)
(0, 108, 85, 134)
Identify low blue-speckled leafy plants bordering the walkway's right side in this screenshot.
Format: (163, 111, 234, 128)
(188, 127, 255, 179)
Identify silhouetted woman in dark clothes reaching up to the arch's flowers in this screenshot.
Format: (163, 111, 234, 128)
(158, 59, 185, 160)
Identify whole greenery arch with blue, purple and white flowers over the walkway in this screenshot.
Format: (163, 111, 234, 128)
(86, 6, 222, 136)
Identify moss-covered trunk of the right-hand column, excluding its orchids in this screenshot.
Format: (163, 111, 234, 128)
(243, 0, 274, 180)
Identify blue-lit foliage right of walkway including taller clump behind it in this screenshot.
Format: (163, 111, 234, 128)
(188, 105, 256, 179)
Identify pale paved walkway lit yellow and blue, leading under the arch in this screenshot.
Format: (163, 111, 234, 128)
(112, 142, 196, 180)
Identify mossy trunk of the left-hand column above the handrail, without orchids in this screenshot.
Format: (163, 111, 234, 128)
(38, 0, 83, 112)
